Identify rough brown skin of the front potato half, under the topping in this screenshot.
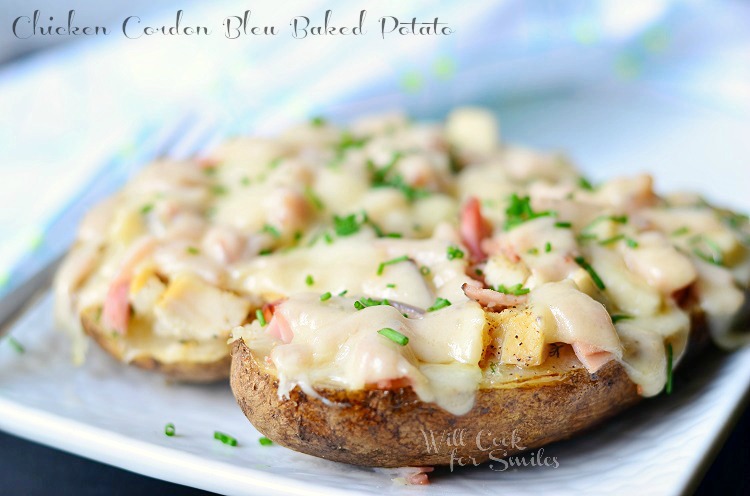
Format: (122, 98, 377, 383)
(230, 340, 641, 467)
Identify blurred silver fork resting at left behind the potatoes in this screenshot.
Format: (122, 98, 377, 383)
(0, 114, 223, 337)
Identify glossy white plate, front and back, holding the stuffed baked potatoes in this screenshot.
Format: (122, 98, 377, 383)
(0, 93, 750, 496)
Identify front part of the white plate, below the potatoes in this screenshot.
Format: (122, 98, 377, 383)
(0, 295, 750, 496)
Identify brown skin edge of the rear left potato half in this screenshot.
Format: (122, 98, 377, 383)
(81, 311, 231, 383)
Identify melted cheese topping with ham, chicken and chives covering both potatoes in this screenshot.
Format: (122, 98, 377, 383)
(55, 109, 750, 414)
